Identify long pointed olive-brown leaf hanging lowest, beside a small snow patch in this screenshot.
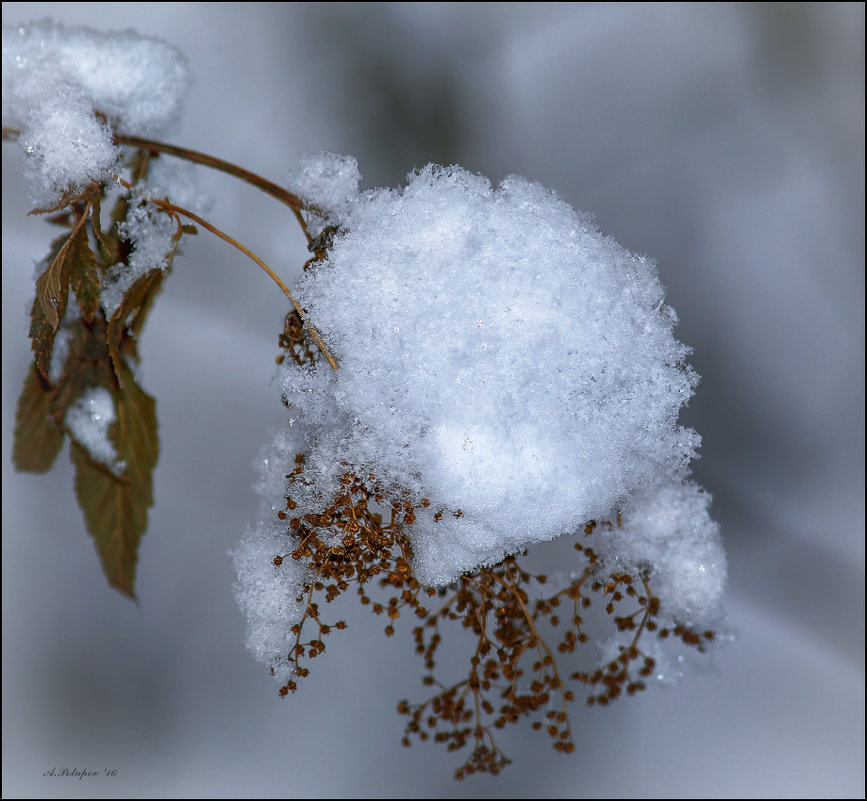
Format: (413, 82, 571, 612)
(70, 363, 159, 598)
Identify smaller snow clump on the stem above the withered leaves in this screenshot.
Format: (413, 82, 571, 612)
(3, 20, 190, 205)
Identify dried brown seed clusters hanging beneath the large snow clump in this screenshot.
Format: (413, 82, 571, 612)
(274, 455, 713, 779)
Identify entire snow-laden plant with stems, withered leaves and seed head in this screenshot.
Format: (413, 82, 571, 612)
(3, 20, 726, 779)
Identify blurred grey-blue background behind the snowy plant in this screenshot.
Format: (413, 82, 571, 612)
(3, 3, 864, 797)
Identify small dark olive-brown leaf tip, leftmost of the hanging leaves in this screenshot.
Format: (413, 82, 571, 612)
(12, 364, 63, 473)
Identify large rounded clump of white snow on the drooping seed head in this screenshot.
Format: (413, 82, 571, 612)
(238, 154, 725, 676)
